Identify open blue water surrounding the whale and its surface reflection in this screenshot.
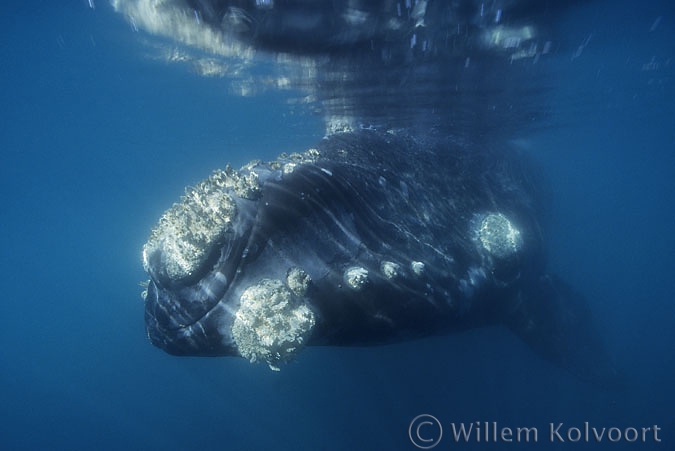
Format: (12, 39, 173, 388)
(0, 0, 675, 450)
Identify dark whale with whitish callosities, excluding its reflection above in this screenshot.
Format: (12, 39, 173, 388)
(143, 130, 609, 378)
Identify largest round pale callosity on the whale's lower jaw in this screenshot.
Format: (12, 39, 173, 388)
(232, 279, 315, 371)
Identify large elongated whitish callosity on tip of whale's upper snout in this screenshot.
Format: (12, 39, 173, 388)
(143, 171, 237, 280)
